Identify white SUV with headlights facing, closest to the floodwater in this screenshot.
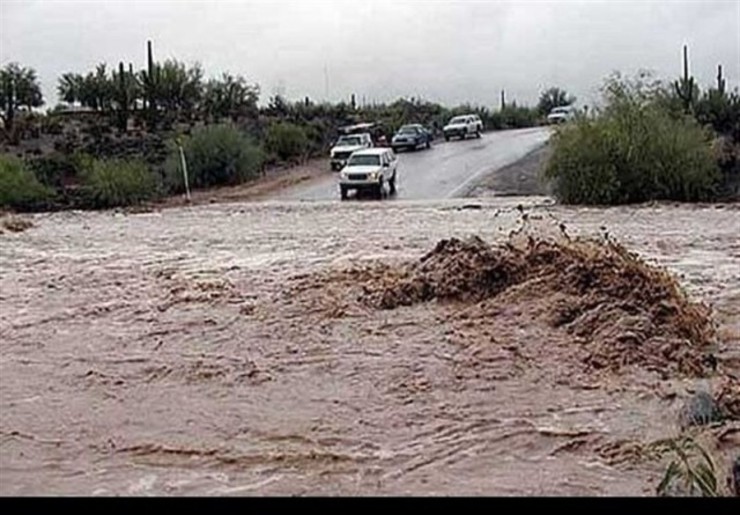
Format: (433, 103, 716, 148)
(339, 148, 398, 200)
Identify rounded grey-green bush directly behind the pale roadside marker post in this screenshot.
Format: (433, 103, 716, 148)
(164, 125, 264, 193)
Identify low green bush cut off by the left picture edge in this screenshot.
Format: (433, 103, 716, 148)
(0, 155, 54, 211)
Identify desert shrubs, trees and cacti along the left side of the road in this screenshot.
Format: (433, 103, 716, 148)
(0, 39, 556, 211)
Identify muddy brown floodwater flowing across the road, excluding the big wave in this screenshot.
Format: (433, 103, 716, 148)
(0, 198, 740, 496)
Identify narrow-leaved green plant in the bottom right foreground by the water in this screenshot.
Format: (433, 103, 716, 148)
(651, 437, 720, 497)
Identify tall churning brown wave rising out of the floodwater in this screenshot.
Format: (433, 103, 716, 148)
(356, 233, 715, 376)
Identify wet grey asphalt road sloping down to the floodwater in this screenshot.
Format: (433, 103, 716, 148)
(278, 127, 551, 200)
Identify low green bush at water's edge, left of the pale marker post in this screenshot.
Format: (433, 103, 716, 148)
(82, 159, 159, 208)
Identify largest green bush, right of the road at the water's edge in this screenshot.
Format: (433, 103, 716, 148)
(545, 76, 719, 204)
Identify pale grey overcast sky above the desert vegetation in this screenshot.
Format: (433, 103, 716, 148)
(0, 0, 740, 106)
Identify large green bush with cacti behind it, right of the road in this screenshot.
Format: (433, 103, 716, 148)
(544, 47, 740, 205)
